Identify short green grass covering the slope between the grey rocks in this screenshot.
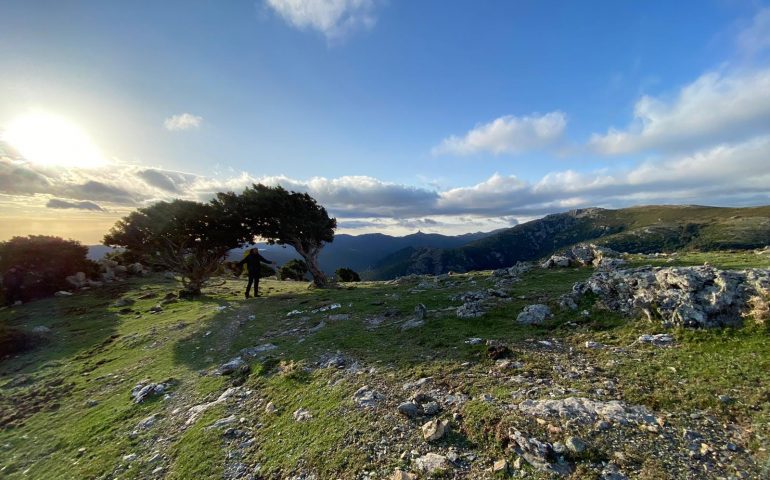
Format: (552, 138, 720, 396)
(0, 249, 770, 479)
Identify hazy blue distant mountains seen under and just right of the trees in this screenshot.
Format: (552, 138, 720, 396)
(225, 232, 495, 279)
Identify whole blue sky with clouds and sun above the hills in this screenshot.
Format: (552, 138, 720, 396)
(0, 0, 770, 244)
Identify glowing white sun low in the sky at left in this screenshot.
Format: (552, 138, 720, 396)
(2, 112, 106, 168)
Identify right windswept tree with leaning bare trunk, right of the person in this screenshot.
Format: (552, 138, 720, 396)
(212, 184, 337, 287)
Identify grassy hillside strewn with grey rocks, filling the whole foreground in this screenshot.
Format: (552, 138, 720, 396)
(0, 246, 770, 479)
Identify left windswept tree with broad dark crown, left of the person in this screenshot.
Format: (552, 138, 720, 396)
(103, 200, 243, 297)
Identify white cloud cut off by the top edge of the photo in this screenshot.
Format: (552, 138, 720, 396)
(265, 0, 377, 41)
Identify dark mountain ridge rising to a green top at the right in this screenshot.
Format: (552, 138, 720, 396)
(368, 205, 770, 279)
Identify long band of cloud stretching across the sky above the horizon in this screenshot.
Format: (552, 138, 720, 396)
(0, 134, 770, 231)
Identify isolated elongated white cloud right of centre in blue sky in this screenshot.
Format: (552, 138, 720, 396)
(432, 111, 567, 155)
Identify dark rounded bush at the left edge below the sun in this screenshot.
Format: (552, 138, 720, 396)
(0, 235, 99, 301)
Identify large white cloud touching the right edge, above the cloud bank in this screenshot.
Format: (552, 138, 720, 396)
(589, 69, 770, 155)
